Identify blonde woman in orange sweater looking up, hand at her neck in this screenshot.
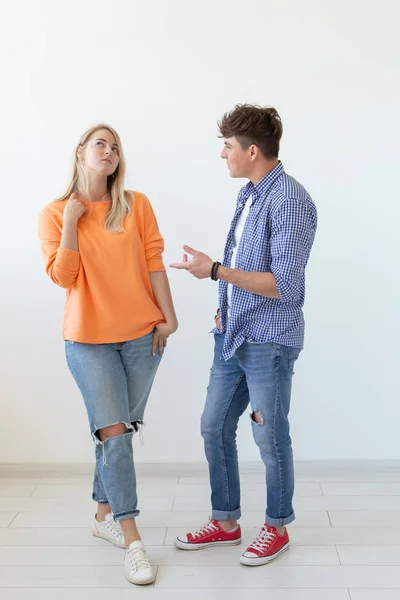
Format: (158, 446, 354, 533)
(39, 125, 178, 584)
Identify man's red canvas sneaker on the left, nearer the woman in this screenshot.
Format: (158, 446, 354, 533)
(175, 520, 242, 550)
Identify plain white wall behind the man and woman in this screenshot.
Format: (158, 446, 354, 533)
(0, 0, 400, 462)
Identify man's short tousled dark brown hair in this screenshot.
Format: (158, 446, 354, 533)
(218, 104, 283, 159)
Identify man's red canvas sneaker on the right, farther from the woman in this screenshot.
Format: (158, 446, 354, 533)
(240, 524, 289, 567)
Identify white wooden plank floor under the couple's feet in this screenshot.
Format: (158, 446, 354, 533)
(0, 462, 400, 600)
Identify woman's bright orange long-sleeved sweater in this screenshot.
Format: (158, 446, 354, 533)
(39, 192, 165, 344)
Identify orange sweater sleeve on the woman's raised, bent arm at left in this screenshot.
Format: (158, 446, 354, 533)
(39, 209, 80, 288)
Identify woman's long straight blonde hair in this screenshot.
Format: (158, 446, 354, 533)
(55, 124, 132, 233)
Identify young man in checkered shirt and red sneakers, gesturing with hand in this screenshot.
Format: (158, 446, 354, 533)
(171, 104, 317, 566)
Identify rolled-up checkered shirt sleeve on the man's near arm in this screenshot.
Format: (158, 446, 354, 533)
(271, 198, 317, 302)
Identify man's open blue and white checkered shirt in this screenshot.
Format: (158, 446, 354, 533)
(217, 163, 317, 360)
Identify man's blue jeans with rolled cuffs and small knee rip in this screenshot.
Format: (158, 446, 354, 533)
(201, 334, 300, 527)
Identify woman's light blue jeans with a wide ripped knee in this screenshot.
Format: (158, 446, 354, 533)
(65, 332, 161, 520)
